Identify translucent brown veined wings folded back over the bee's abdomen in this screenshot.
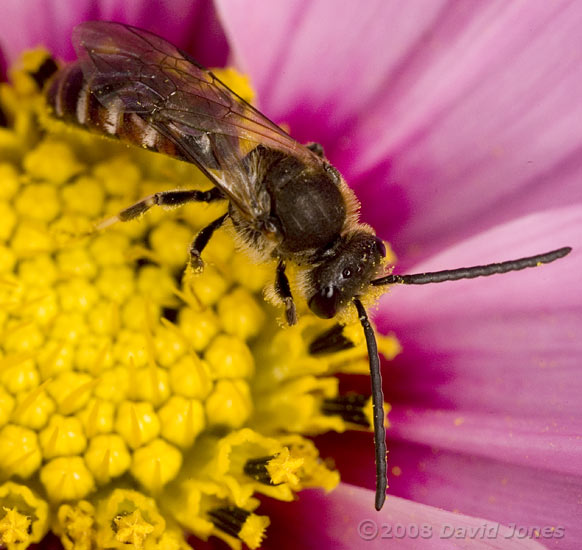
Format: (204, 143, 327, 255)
(73, 21, 321, 218)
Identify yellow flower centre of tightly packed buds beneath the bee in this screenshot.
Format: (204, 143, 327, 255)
(0, 52, 399, 550)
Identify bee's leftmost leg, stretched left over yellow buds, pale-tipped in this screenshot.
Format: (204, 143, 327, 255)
(95, 187, 225, 231)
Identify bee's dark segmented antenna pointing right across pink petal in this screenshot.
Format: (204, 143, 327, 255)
(370, 246, 572, 286)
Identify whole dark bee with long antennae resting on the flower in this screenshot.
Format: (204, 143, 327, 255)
(46, 21, 571, 510)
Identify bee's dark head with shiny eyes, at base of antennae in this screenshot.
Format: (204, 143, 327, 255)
(309, 231, 386, 319)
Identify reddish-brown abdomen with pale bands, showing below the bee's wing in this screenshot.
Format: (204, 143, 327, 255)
(46, 63, 192, 160)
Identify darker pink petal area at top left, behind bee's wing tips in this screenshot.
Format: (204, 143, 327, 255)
(0, 0, 228, 65)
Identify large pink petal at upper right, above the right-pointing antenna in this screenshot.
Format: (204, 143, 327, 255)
(218, 0, 582, 270)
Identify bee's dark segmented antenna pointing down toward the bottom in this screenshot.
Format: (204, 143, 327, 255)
(354, 298, 388, 511)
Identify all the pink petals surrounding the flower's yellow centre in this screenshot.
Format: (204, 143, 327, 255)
(0, 0, 582, 549)
